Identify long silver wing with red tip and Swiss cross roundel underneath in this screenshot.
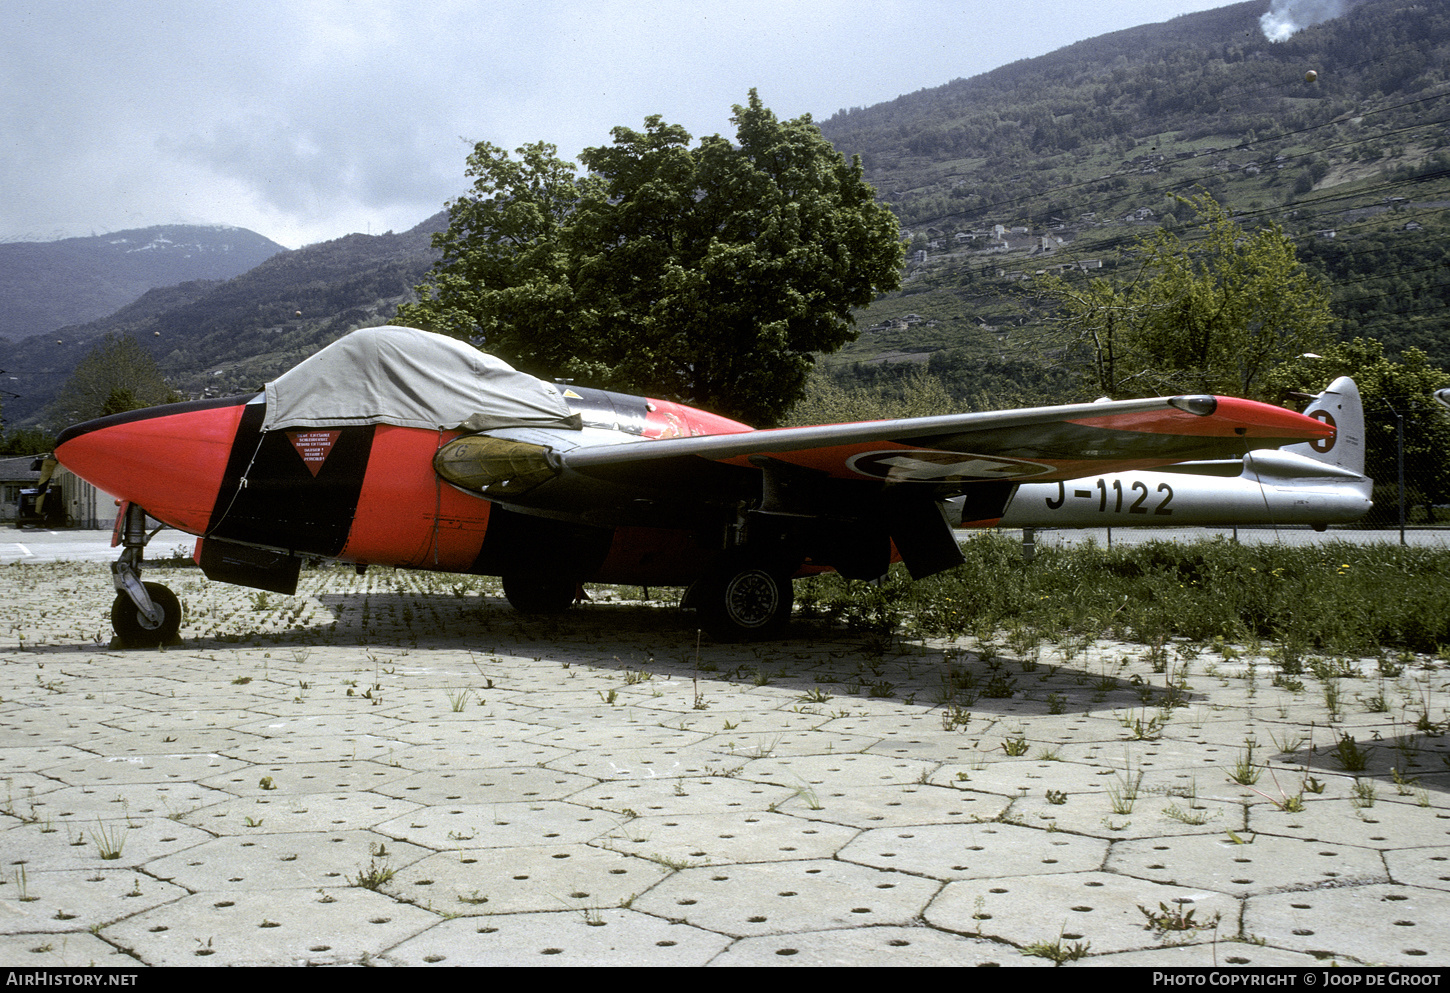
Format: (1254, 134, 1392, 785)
(558, 396, 1334, 486)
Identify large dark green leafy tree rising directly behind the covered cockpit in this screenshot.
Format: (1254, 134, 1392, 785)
(397, 90, 902, 423)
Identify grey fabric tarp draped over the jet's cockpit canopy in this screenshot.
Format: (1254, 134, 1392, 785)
(262, 326, 580, 432)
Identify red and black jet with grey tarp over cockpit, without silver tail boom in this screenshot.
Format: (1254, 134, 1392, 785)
(55, 328, 1334, 645)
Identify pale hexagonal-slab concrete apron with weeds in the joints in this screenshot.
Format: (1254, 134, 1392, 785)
(0, 562, 1450, 967)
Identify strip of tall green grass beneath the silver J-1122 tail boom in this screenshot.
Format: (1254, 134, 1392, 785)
(798, 533, 1450, 657)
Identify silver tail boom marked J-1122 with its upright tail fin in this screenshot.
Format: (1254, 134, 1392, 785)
(948, 377, 1375, 531)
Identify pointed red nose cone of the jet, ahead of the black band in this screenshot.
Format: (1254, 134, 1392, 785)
(55, 397, 247, 533)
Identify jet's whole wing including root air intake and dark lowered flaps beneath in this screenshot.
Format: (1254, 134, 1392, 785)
(434, 396, 1334, 578)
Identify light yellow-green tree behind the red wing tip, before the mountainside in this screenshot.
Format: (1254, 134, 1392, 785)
(1047, 194, 1333, 399)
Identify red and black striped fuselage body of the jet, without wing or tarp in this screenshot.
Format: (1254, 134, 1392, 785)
(55, 387, 755, 589)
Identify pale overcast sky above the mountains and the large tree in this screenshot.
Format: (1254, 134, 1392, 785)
(0, 0, 1247, 248)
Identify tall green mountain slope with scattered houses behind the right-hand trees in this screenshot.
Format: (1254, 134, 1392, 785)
(822, 0, 1450, 389)
